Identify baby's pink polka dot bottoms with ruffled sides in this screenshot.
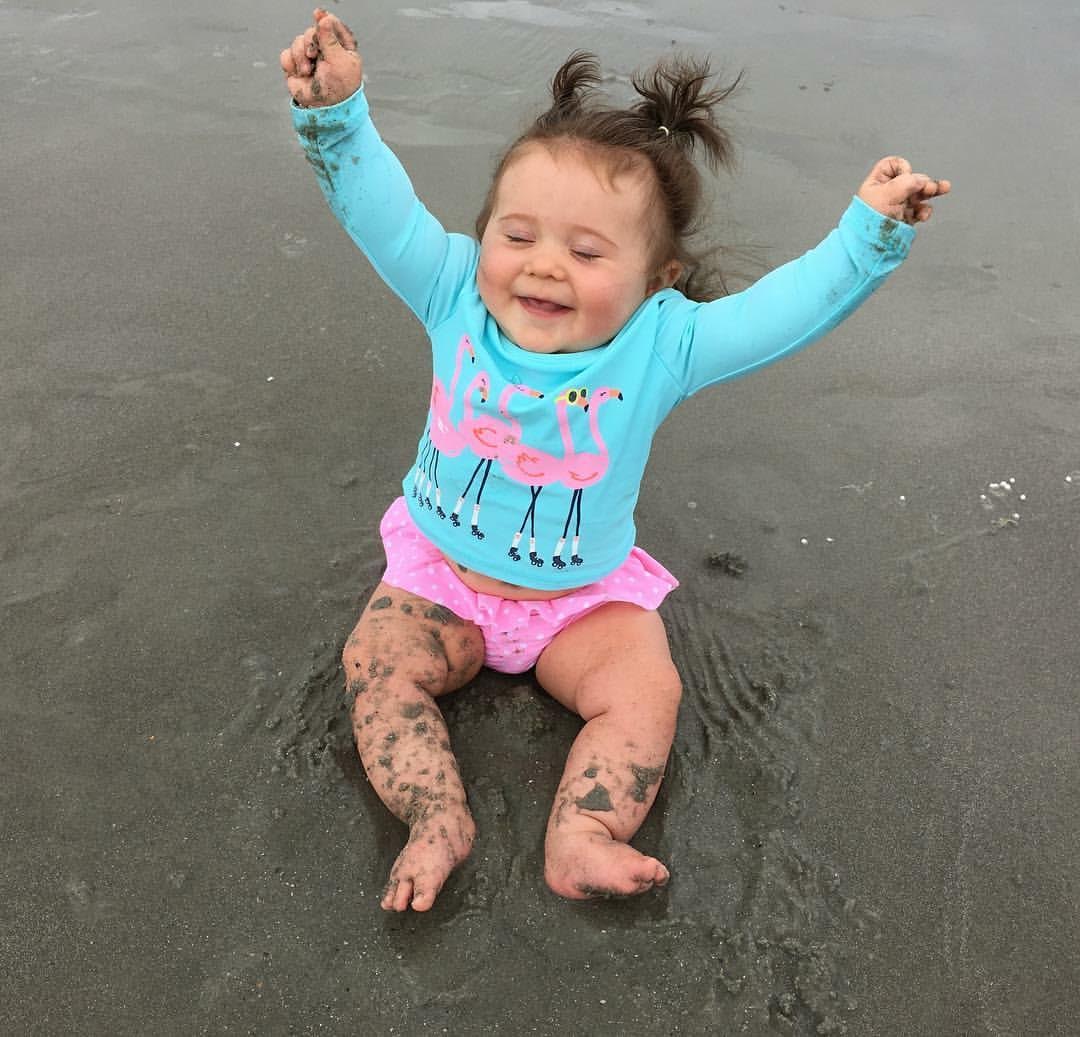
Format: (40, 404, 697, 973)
(379, 497, 678, 673)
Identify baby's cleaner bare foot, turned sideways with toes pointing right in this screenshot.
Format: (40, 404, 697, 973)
(544, 819, 670, 900)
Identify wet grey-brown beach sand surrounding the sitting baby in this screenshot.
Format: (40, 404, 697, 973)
(0, 0, 1080, 1037)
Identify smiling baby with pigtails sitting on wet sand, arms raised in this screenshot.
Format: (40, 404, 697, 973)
(281, 10, 949, 911)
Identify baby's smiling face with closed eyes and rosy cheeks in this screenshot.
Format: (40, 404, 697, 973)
(476, 145, 674, 353)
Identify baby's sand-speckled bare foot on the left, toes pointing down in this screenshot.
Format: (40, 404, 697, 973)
(381, 810, 476, 911)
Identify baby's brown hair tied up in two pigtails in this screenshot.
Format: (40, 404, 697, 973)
(476, 51, 742, 300)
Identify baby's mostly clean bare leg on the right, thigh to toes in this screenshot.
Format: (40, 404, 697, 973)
(537, 603, 681, 900)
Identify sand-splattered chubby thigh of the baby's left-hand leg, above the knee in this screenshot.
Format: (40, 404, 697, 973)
(342, 582, 484, 697)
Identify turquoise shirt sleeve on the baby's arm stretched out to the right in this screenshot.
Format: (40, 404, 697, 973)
(657, 198, 915, 399)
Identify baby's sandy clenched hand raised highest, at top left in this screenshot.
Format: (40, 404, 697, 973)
(281, 8, 364, 108)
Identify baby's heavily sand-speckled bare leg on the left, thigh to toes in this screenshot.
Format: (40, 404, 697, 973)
(342, 583, 484, 911)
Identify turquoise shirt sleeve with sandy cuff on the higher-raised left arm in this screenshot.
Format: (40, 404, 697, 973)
(293, 90, 477, 327)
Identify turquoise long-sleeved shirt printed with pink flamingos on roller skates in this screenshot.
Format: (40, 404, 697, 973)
(293, 91, 915, 591)
